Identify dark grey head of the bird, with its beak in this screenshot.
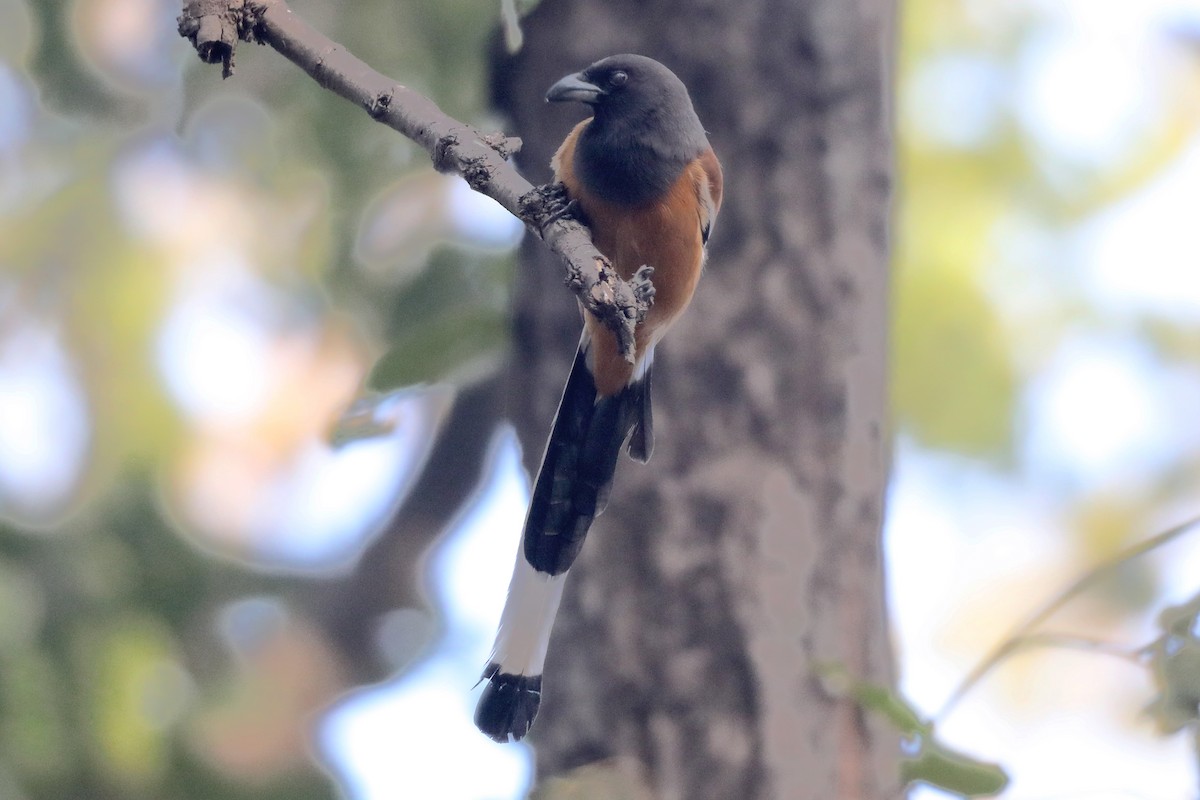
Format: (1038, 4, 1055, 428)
(546, 54, 709, 205)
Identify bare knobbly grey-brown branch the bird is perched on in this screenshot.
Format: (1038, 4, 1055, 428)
(179, 0, 654, 362)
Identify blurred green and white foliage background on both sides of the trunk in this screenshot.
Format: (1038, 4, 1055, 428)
(0, 0, 1200, 800)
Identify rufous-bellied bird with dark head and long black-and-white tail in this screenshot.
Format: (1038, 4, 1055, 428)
(475, 54, 724, 742)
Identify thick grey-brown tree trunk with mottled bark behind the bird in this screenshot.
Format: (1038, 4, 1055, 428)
(496, 0, 896, 800)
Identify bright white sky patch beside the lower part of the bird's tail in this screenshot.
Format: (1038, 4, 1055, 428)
(320, 429, 532, 800)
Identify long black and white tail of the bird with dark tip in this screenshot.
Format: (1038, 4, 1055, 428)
(475, 339, 654, 741)
